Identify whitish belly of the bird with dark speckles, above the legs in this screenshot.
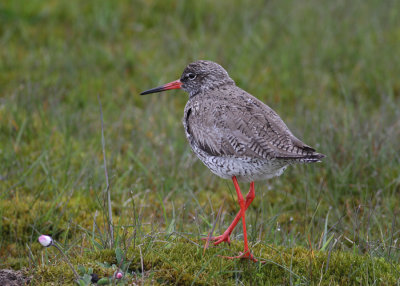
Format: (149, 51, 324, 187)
(193, 144, 289, 182)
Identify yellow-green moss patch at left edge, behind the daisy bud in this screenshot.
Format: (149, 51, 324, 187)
(0, 195, 111, 269)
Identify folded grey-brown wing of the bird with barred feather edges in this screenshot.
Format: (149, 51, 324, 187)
(185, 89, 323, 161)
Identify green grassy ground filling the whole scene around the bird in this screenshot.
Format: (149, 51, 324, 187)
(0, 0, 400, 285)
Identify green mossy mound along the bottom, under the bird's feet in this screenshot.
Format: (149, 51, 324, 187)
(34, 239, 400, 285)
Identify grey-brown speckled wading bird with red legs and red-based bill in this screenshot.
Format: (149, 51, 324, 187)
(141, 60, 325, 262)
